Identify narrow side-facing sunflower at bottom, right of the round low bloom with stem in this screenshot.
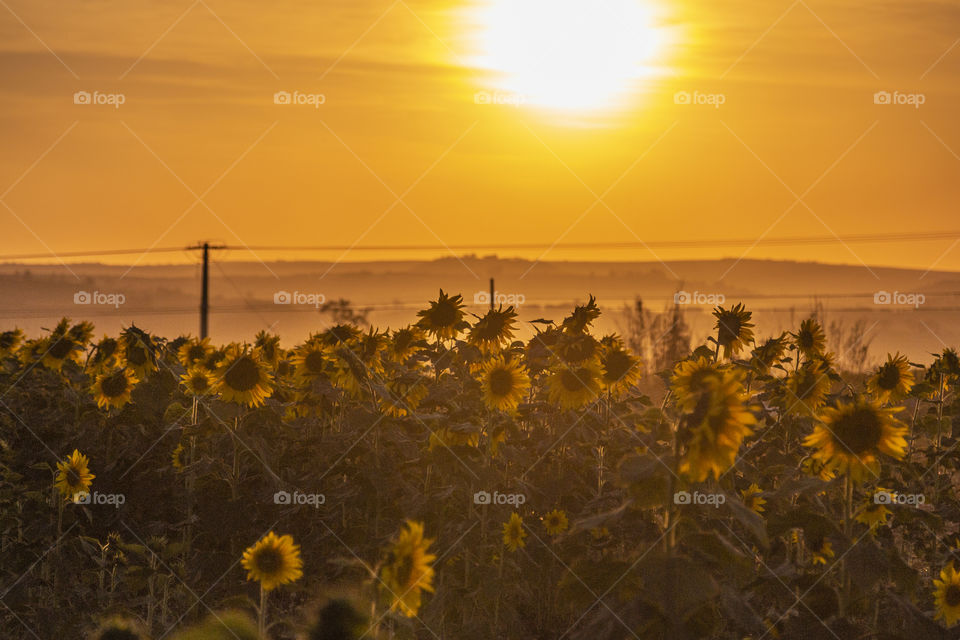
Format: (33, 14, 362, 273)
(380, 520, 437, 618)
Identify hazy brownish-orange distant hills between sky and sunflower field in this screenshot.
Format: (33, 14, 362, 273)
(0, 256, 960, 358)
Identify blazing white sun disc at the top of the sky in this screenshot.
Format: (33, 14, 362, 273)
(473, 0, 669, 111)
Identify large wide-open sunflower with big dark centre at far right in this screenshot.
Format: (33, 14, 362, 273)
(803, 397, 907, 479)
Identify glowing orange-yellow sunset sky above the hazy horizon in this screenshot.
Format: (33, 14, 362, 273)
(0, 0, 960, 270)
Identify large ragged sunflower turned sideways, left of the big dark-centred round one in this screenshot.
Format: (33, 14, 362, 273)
(679, 370, 757, 482)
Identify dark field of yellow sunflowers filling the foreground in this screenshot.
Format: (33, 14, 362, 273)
(0, 291, 960, 640)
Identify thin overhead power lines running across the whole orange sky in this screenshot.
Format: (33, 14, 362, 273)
(0, 231, 960, 262)
